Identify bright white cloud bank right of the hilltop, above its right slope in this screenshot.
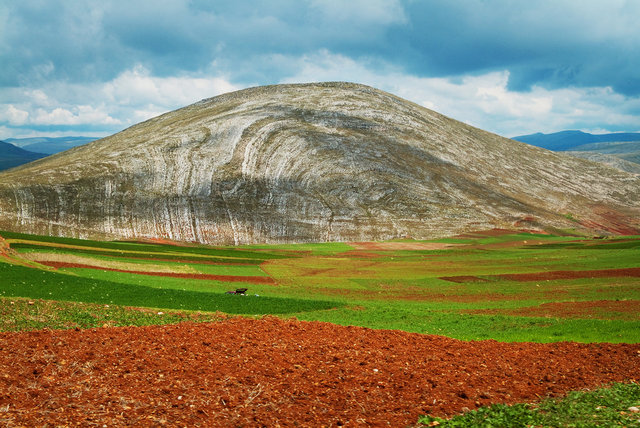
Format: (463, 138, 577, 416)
(283, 50, 640, 136)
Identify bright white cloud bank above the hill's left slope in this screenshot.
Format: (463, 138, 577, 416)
(0, 66, 238, 138)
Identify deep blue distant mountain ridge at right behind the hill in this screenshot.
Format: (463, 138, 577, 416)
(513, 131, 640, 151)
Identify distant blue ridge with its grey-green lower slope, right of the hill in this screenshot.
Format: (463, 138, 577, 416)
(512, 131, 640, 174)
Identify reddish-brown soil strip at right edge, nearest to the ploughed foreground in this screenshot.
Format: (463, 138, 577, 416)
(464, 300, 640, 320)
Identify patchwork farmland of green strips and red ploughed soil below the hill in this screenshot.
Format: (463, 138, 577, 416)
(0, 231, 640, 426)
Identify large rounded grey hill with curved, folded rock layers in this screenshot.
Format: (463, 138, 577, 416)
(0, 83, 640, 244)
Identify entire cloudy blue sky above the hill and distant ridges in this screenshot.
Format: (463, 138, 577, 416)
(0, 0, 640, 139)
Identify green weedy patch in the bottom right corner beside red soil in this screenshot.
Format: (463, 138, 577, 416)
(418, 383, 640, 428)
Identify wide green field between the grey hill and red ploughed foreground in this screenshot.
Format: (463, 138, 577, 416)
(0, 232, 640, 343)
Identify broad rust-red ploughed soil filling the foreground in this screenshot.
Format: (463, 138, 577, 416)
(0, 317, 640, 427)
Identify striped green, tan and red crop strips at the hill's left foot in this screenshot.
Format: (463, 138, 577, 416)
(0, 233, 336, 314)
